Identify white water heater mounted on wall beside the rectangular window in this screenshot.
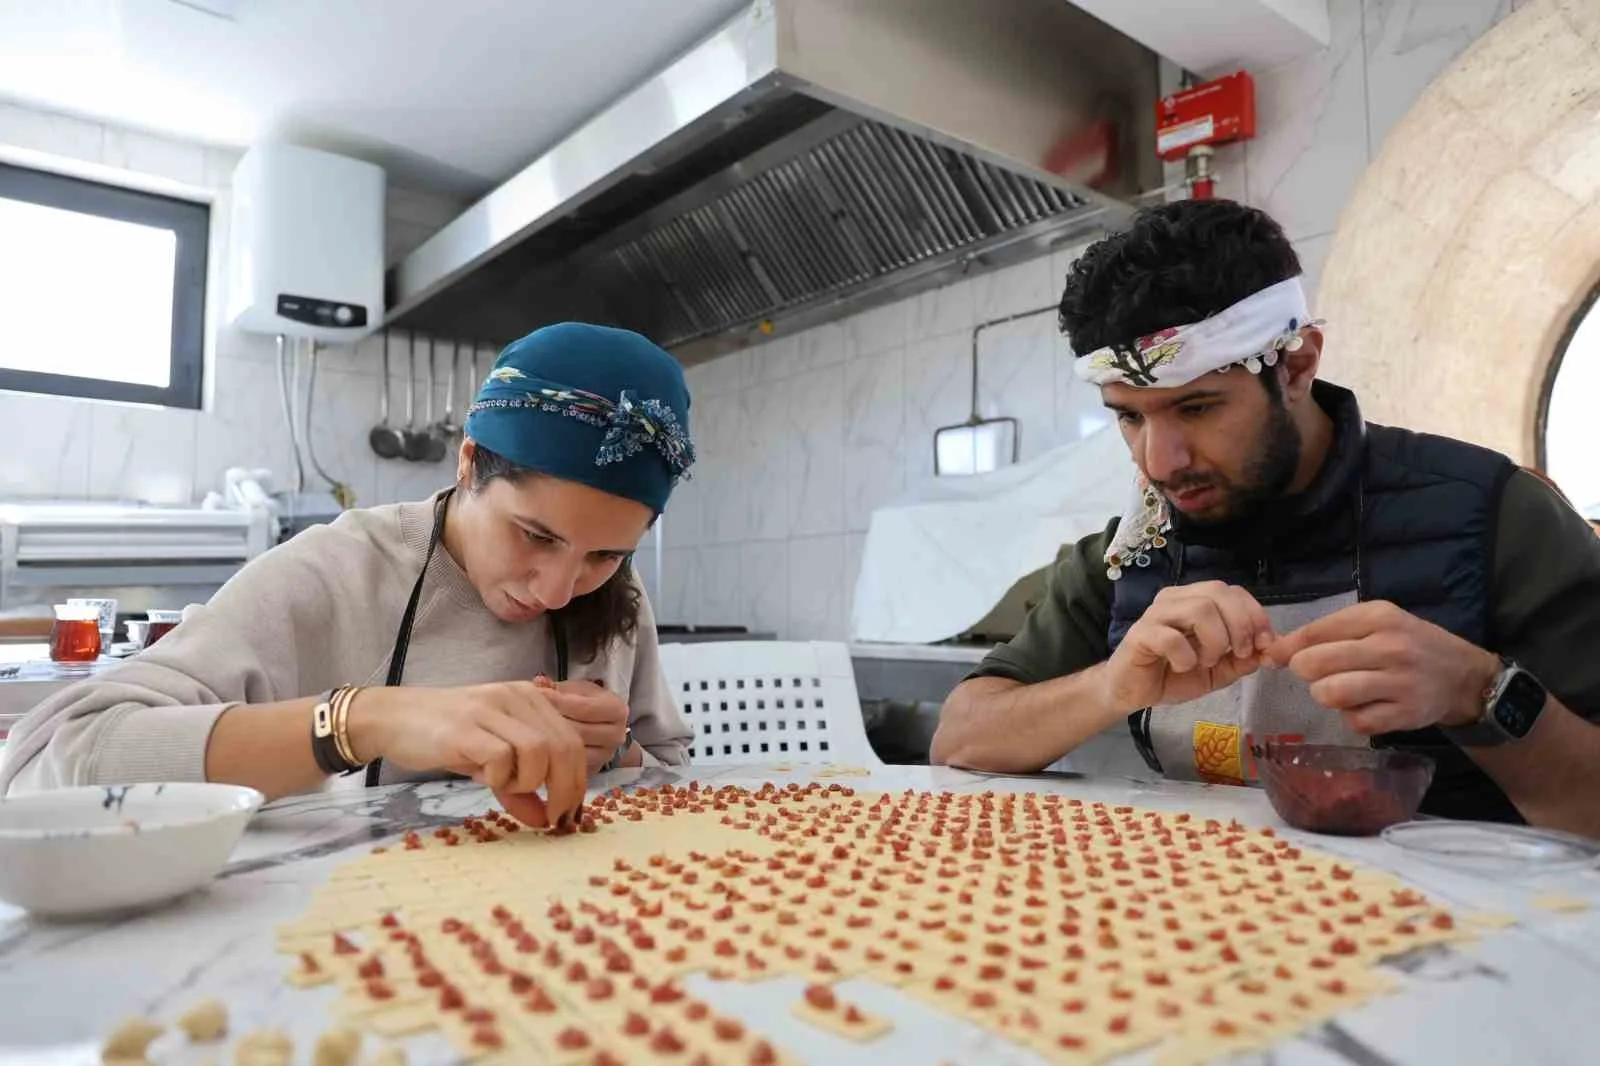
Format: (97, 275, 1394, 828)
(227, 144, 384, 344)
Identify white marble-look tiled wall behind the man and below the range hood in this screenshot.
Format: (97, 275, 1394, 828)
(662, 0, 1512, 639)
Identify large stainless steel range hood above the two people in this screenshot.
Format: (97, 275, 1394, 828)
(387, 0, 1160, 362)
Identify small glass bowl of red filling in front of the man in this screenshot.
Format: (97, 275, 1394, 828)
(1256, 744, 1434, 837)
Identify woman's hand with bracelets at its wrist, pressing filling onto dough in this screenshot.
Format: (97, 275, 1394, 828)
(349, 682, 588, 826)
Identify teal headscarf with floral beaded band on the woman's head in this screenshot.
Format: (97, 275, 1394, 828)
(466, 322, 694, 514)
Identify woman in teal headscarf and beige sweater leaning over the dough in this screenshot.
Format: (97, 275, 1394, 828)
(0, 323, 694, 824)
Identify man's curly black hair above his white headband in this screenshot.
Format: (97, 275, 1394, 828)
(1059, 200, 1301, 361)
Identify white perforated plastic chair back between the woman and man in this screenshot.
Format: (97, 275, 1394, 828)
(661, 640, 878, 767)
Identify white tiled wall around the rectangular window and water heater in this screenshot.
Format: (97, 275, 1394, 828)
(0, 104, 461, 504)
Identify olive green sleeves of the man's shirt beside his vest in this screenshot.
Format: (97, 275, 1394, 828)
(971, 471, 1600, 720)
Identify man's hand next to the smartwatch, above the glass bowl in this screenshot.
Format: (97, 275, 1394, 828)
(1266, 600, 1501, 736)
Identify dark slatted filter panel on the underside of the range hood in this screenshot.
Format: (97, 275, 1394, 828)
(584, 122, 1090, 346)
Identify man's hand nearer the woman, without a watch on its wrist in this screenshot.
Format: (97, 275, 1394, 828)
(1104, 581, 1274, 714)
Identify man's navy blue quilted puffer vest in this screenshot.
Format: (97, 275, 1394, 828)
(1109, 381, 1522, 821)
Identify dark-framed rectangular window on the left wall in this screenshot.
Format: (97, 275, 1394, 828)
(0, 163, 211, 408)
